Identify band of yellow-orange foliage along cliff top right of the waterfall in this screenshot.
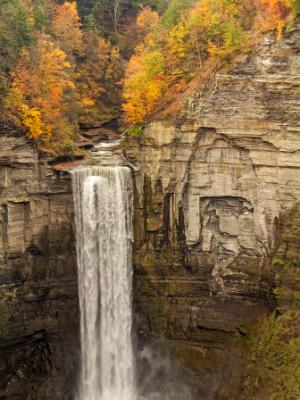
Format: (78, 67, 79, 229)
(123, 0, 300, 124)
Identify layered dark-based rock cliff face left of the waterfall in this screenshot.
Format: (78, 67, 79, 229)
(0, 135, 79, 400)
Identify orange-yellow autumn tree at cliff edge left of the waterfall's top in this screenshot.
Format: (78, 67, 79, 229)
(6, 34, 75, 139)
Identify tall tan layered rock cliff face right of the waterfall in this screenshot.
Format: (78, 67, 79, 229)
(128, 26, 300, 399)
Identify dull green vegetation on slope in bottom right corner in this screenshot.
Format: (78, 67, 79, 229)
(250, 311, 300, 400)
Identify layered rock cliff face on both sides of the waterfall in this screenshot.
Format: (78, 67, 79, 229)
(0, 21, 300, 400)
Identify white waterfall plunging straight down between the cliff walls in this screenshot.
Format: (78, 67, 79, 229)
(72, 167, 136, 400)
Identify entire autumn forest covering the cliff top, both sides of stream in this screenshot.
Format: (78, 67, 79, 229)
(0, 0, 299, 151)
